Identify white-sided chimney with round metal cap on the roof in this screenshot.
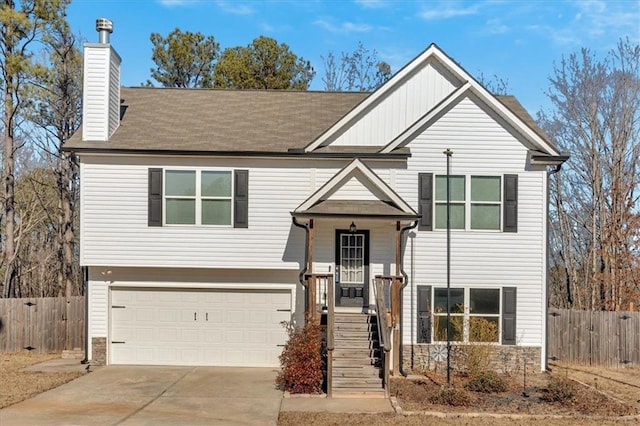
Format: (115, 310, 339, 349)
(82, 18, 121, 142)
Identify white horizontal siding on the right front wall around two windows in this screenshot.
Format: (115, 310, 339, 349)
(396, 98, 546, 346)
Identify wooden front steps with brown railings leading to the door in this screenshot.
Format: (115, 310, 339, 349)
(305, 274, 402, 398)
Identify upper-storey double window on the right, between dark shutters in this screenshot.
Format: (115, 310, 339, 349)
(435, 176, 502, 231)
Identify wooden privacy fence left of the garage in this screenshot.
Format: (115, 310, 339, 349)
(0, 296, 85, 352)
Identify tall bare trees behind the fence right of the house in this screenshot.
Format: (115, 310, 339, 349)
(539, 39, 640, 310)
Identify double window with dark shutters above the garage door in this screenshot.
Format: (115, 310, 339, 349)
(164, 170, 233, 226)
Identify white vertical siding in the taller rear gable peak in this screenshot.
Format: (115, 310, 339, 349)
(333, 62, 457, 146)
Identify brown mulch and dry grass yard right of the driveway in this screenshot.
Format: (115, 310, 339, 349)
(279, 366, 640, 426)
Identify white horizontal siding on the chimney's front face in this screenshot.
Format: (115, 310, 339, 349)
(82, 44, 109, 141)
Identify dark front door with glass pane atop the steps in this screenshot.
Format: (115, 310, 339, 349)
(336, 229, 369, 308)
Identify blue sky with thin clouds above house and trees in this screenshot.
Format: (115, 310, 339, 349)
(67, 0, 640, 114)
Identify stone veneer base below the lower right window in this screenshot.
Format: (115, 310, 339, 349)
(402, 343, 541, 374)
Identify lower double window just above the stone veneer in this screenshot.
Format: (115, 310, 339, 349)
(432, 287, 500, 343)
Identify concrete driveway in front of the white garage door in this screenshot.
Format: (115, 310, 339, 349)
(0, 366, 282, 426)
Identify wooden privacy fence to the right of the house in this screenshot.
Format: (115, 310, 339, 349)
(547, 308, 640, 368)
